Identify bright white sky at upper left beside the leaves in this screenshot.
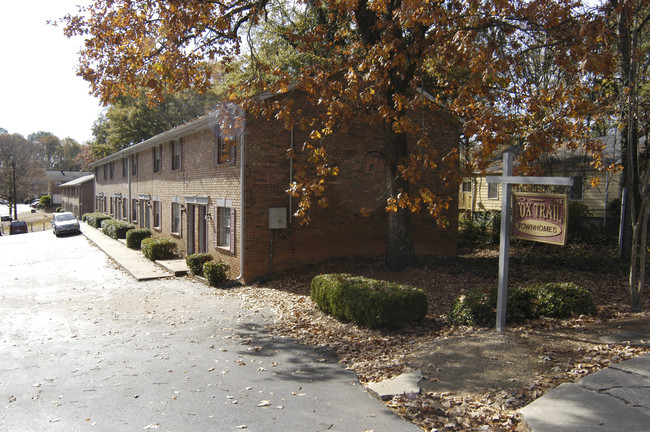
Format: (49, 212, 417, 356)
(0, 0, 102, 143)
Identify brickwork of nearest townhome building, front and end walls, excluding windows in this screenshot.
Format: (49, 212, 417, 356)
(95, 93, 458, 282)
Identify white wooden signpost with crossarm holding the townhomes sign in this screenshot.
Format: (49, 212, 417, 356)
(486, 152, 573, 331)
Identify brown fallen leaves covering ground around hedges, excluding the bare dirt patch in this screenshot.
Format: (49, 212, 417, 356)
(215, 246, 650, 431)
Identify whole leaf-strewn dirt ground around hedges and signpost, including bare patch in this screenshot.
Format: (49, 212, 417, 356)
(225, 244, 650, 431)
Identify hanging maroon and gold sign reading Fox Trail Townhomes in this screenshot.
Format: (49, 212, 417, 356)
(512, 192, 569, 246)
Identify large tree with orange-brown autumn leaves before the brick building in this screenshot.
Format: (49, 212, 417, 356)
(64, 0, 632, 280)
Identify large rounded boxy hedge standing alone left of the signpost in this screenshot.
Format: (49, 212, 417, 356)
(311, 274, 428, 328)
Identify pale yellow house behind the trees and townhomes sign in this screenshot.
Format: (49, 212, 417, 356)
(458, 134, 622, 224)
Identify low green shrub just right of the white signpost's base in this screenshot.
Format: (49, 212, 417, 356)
(528, 283, 596, 318)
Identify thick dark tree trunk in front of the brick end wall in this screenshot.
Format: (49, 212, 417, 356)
(384, 125, 417, 271)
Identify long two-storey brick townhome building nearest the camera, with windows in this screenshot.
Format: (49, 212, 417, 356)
(91, 92, 459, 282)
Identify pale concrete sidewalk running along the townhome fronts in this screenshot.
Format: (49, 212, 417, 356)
(81, 222, 187, 281)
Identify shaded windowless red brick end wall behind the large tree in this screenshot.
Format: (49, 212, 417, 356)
(240, 93, 459, 277)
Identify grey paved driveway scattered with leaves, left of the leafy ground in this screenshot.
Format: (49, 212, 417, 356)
(0, 231, 419, 432)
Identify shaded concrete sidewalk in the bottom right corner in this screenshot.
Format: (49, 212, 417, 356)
(521, 354, 650, 432)
